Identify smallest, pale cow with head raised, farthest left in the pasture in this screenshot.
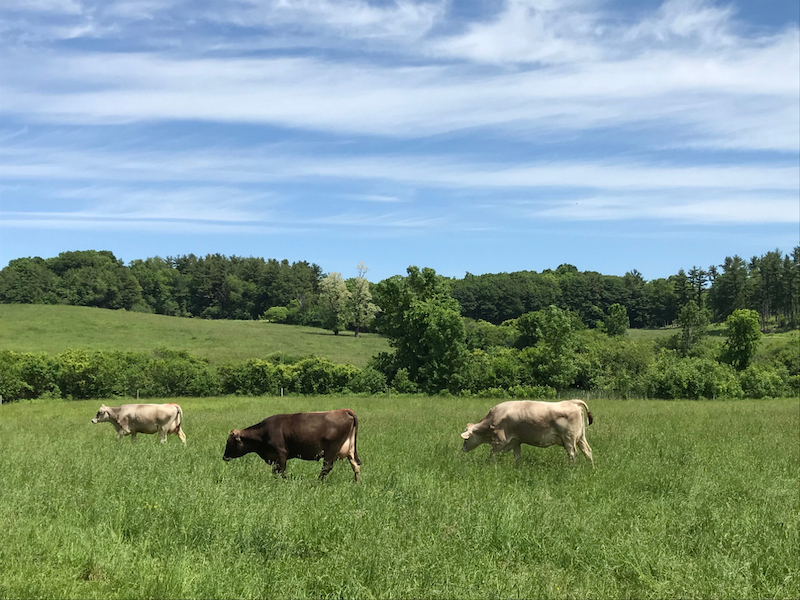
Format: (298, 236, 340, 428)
(92, 404, 186, 446)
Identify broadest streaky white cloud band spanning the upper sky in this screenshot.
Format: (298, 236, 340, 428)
(0, 32, 800, 151)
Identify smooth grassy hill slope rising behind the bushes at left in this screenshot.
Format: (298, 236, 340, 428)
(0, 304, 389, 367)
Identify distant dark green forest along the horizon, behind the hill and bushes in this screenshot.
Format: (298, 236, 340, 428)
(0, 246, 800, 331)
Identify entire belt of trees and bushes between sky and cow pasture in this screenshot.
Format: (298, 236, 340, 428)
(0, 247, 800, 399)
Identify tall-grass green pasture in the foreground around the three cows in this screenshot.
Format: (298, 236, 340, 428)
(0, 396, 800, 598)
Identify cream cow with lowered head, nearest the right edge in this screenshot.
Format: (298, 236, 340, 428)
(461, 399, 594, 466)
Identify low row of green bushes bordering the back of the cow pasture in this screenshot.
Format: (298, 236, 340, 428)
(0, 341, 800, 401)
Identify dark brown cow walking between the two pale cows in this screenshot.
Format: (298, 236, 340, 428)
(222, 408, 361, 481)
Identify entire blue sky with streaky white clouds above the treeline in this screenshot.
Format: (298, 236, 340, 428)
(0, 0, 800, 281)
